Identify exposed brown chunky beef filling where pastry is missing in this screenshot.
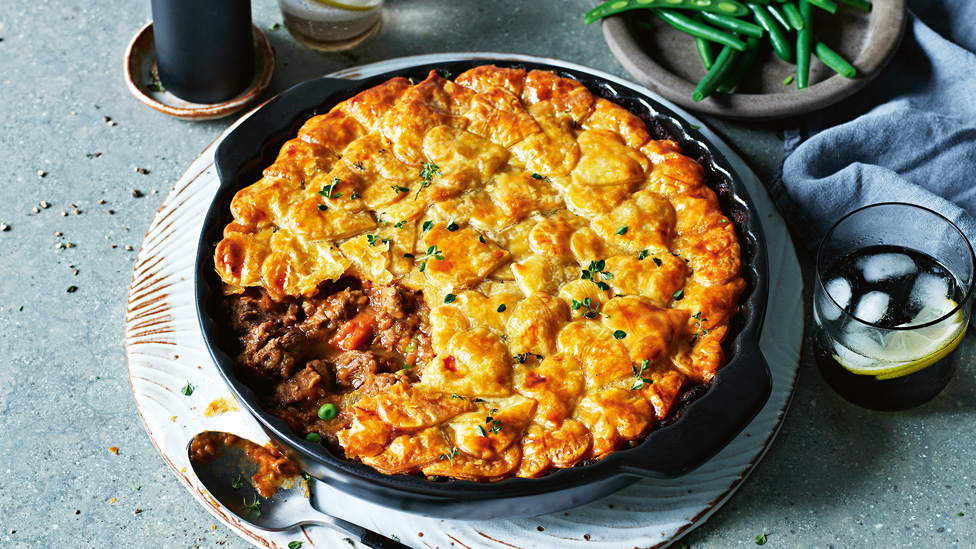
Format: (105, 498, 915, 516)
(223, 278, 434, 456)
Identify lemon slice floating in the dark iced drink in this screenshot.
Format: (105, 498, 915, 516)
(834, 299, 966, 380)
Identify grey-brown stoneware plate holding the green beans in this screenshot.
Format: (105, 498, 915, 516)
(603, 0, 906, 120)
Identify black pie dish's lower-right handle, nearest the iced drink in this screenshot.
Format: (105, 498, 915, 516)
(620, 343, 772, 478)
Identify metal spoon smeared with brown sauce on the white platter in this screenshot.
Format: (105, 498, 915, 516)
(186, 432, 410, 549)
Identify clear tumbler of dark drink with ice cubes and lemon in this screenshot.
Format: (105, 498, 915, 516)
(813, 203, 976, 410)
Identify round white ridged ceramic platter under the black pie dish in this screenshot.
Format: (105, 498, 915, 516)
(126, 53, 803, 549)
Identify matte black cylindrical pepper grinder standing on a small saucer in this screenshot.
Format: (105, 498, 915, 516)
(152, 0, 254, 104)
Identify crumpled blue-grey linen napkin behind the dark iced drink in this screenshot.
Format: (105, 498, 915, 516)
(769, 0, 976, 251)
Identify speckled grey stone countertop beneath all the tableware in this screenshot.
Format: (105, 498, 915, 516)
(0, 0, 976, 549)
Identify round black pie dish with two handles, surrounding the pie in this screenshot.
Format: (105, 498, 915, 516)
(195, 59, 772, 520)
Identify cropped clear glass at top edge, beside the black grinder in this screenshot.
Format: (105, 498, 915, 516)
(278, 0, 384, 51)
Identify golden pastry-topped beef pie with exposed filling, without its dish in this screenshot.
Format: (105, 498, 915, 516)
(215, 66, 745, 481)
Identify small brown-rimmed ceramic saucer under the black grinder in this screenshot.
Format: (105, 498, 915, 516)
(125, 22, 275, 120)
